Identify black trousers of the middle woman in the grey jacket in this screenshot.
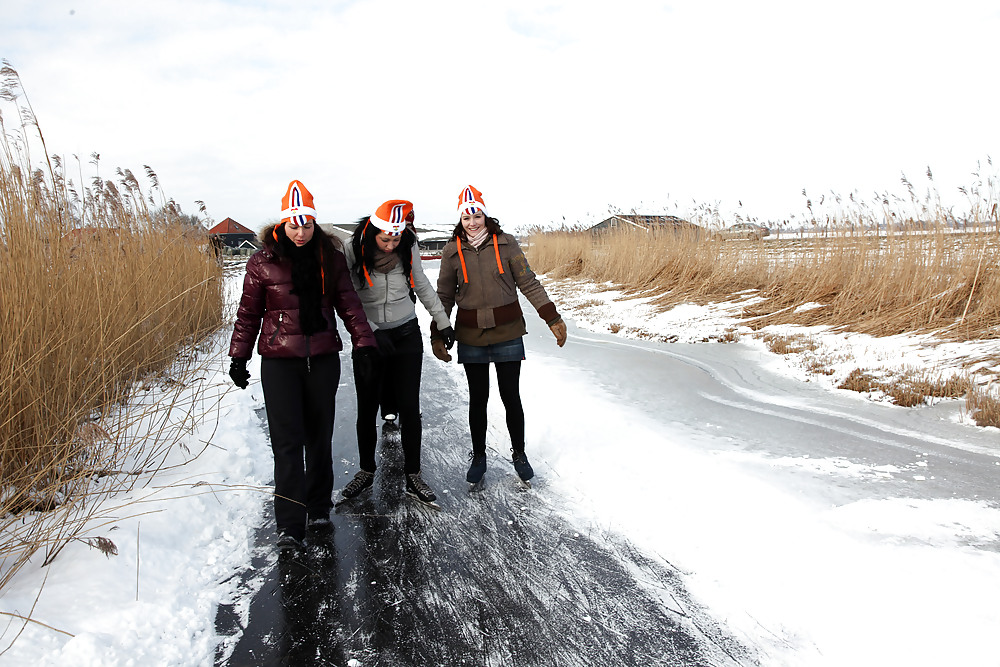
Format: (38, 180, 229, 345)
(354, 320, 424, 474)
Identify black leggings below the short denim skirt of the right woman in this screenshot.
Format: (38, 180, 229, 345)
(463, 361, 524, 456)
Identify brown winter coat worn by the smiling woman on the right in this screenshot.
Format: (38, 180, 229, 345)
(432, 234, 559, 346)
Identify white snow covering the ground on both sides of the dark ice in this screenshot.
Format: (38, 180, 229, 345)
(0, 262, 1000, 666)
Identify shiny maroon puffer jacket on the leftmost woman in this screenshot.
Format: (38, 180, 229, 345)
(229, 232, 377, 359)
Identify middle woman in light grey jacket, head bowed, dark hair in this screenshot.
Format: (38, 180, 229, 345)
(341, 199, 454, 502)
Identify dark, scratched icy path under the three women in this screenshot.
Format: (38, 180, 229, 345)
(219, 364, 750, 667)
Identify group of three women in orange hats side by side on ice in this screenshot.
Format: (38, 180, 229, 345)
(229, 181, 566, 549)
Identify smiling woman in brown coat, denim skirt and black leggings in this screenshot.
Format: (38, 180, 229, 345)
(431, 185, 566, 484)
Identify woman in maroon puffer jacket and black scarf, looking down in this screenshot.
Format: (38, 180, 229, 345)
(229, 181, 377, 550)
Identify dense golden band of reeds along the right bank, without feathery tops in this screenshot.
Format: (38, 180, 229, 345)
(528, 217, 1000, 340)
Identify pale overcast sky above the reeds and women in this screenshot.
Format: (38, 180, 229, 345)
(0, 0, 1000, 228)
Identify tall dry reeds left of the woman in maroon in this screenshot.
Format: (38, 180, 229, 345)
(0, 61, 223, 600)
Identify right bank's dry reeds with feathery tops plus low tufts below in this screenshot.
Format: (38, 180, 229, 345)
(527, 170, 1000, 424)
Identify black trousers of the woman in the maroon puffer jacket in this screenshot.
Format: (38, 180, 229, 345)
(260, 354, 340, 539)
